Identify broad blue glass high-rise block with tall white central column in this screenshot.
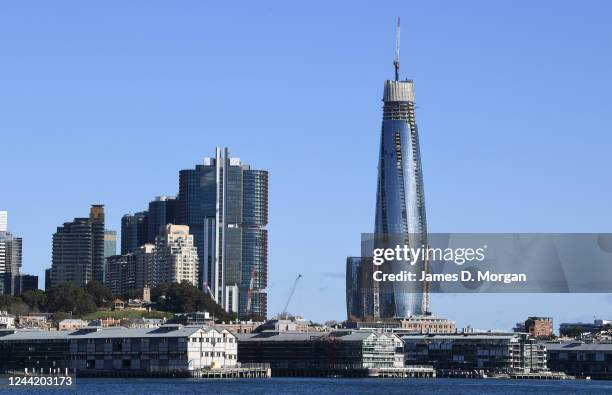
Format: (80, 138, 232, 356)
(177, 148, 268, 318)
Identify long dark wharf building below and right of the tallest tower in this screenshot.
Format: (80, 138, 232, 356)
(402, 332, 547, 373)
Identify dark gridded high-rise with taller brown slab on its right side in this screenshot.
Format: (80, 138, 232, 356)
(49, 205, 104, 288)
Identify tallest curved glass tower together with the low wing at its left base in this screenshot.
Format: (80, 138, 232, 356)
(346, 18, 429, 321)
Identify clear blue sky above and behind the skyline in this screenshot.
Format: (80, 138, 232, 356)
(0, 0, 612, 329)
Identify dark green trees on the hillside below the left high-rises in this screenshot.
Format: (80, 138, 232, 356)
(0, 281, 236, 321)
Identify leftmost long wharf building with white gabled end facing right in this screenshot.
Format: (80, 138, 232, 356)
(0, 325, 237, 375)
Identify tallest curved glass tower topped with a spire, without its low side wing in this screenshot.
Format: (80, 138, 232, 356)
(374, 19, 429, 318)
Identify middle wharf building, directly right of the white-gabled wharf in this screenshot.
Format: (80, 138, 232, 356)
(237, 330, 404, 376)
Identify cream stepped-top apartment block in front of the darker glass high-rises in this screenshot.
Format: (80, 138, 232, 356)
(151, 224, 199, 286)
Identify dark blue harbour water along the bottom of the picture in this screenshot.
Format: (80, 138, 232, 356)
(4, 378, 612, 395)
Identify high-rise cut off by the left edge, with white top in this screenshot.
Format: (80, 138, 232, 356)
(0, 211, 22, 295)
